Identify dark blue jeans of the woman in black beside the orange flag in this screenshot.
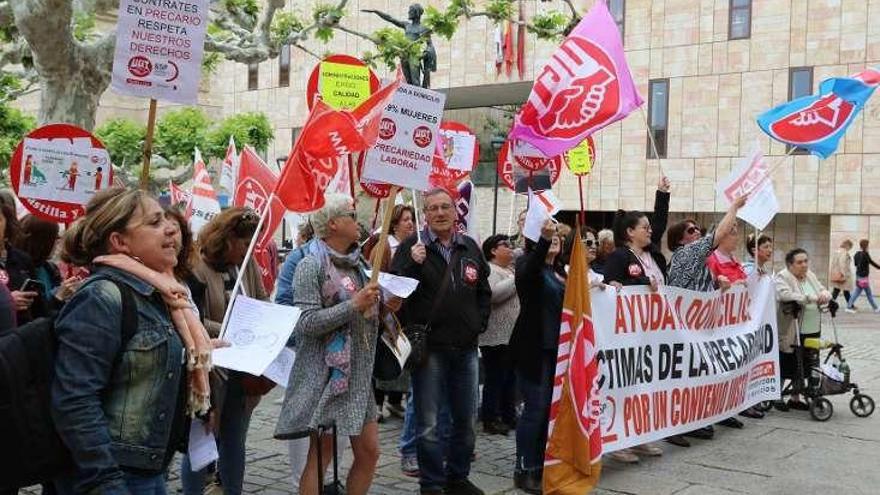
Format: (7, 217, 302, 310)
(516, 351, 556, 471)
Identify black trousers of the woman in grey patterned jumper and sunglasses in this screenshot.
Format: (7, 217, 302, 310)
(480, 345, 516, 425)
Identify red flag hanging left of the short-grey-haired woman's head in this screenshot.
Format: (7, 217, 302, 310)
(232, 146, 285, 292)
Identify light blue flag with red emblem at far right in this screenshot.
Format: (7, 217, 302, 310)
(758, 68, 880, 159)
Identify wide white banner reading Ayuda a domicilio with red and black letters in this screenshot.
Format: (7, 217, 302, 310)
(590, 277, 782, 453)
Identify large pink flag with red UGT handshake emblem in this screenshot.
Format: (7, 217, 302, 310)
(508, 2, 643, 157)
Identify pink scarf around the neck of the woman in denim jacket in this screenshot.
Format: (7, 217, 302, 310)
(94, 254, 213, 417)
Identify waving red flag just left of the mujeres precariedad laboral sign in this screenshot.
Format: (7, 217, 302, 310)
(275, 71, 402, 212)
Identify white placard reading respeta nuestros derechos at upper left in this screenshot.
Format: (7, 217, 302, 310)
(111, 0, 208, 105)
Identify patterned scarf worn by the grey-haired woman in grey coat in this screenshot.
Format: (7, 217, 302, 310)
(312, 239, 366, 396)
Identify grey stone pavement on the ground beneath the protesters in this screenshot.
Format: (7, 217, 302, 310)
(24, 313, 880, 495)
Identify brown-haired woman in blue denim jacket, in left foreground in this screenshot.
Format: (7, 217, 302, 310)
(52, 189, 188, 495)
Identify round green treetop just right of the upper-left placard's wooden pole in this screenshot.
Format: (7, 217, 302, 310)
(153, 107, 211, 166)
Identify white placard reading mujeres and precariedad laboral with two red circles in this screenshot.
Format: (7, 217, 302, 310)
(363, 84, 446, 191)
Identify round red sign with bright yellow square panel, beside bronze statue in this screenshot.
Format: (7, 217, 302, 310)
(306, 54, 379, 110)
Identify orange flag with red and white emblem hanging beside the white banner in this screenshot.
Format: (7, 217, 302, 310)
(544, 227, 602, 495)
